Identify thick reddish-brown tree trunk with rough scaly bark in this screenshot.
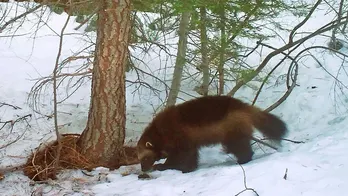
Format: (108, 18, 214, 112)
(78, 0, 130, 167)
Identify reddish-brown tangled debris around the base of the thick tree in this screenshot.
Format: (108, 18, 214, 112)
(23, 134, 139, 181)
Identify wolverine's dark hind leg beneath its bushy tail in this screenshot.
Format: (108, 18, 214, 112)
(222, 122, 254, 164)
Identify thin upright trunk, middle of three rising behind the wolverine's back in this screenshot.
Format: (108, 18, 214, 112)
(200, 7, 210, 96)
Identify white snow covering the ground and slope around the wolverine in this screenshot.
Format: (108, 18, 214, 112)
(0, 1, 348, 196)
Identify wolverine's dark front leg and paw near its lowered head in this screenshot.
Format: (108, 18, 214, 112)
(154, 148, 198, 173)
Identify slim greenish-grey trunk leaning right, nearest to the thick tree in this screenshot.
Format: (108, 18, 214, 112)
(166, 12, 191, 107)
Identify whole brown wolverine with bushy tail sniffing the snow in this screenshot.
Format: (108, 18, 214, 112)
(137, 96, 287, 173)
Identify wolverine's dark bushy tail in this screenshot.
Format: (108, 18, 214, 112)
(253, 110, 287, 141)
